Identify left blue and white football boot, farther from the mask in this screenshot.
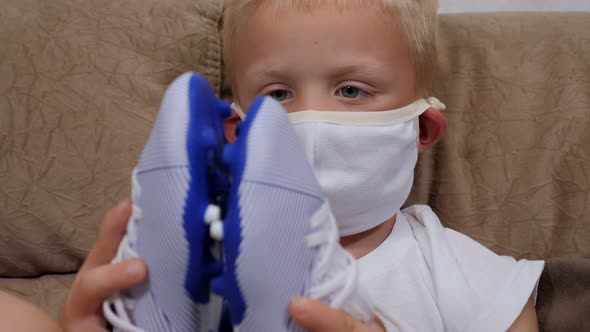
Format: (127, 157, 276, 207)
(103, 73, 230, 332)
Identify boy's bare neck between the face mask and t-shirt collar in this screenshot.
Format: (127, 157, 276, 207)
(340, 215, 397, 259)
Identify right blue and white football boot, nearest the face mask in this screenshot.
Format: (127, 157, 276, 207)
(211, 97, 374, 332)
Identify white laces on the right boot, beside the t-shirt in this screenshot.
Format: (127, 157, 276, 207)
(305, 202, 373, 320)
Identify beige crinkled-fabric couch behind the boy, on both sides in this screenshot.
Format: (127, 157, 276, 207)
(0, 0, 590, 331)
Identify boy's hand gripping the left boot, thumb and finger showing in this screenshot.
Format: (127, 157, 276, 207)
(60, 200, 147, 332)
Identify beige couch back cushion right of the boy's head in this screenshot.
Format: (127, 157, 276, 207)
(411, 13, 590, 259)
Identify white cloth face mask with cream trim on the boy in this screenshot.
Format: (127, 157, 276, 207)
(235, 98, 444, 236)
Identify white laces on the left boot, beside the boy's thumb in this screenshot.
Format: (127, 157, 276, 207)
(102, 170, 145, 332)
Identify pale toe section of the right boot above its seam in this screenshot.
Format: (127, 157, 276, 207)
(242, 98, 322, 197)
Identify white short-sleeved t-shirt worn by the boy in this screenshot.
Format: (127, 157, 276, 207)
(359, 205, 544, 332)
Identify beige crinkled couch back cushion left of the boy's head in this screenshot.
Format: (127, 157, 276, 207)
(0, 0, 222, 277)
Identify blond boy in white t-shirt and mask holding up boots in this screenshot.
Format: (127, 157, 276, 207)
(0, 0, 542, 331)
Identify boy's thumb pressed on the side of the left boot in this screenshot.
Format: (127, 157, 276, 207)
(67, 258, 147, 317)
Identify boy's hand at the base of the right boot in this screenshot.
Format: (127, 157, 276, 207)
(289, 298, 385, 332)
